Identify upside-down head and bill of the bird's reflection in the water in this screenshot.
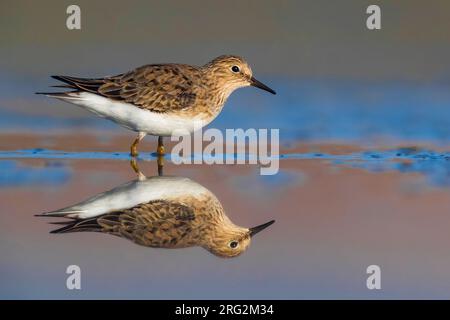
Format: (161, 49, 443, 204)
(204, 220, 275, 258)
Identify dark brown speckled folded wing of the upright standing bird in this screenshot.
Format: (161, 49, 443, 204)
(54, 64, 200, 113)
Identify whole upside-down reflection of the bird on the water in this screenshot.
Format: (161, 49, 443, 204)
(37, 176, 274, 257)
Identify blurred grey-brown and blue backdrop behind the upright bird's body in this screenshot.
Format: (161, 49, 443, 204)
(0, 0, 450, 143)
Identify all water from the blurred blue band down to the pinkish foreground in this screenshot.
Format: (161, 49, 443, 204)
(0, 79, 450, 299)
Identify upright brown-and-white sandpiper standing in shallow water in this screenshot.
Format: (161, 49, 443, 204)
(40, 56, 275, 156)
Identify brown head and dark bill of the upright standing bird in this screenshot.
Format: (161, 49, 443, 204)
(203, 55, 276, 94)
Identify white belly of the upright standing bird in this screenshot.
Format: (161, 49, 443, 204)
(57, 92, 212, 136)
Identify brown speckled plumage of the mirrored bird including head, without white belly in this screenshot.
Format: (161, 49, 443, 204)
(48, 180, 274, 257)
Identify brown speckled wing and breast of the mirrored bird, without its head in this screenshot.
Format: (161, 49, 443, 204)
(57, 197, 225, 248)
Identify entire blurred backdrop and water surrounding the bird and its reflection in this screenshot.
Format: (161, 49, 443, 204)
(0, 0, 450, 299)
